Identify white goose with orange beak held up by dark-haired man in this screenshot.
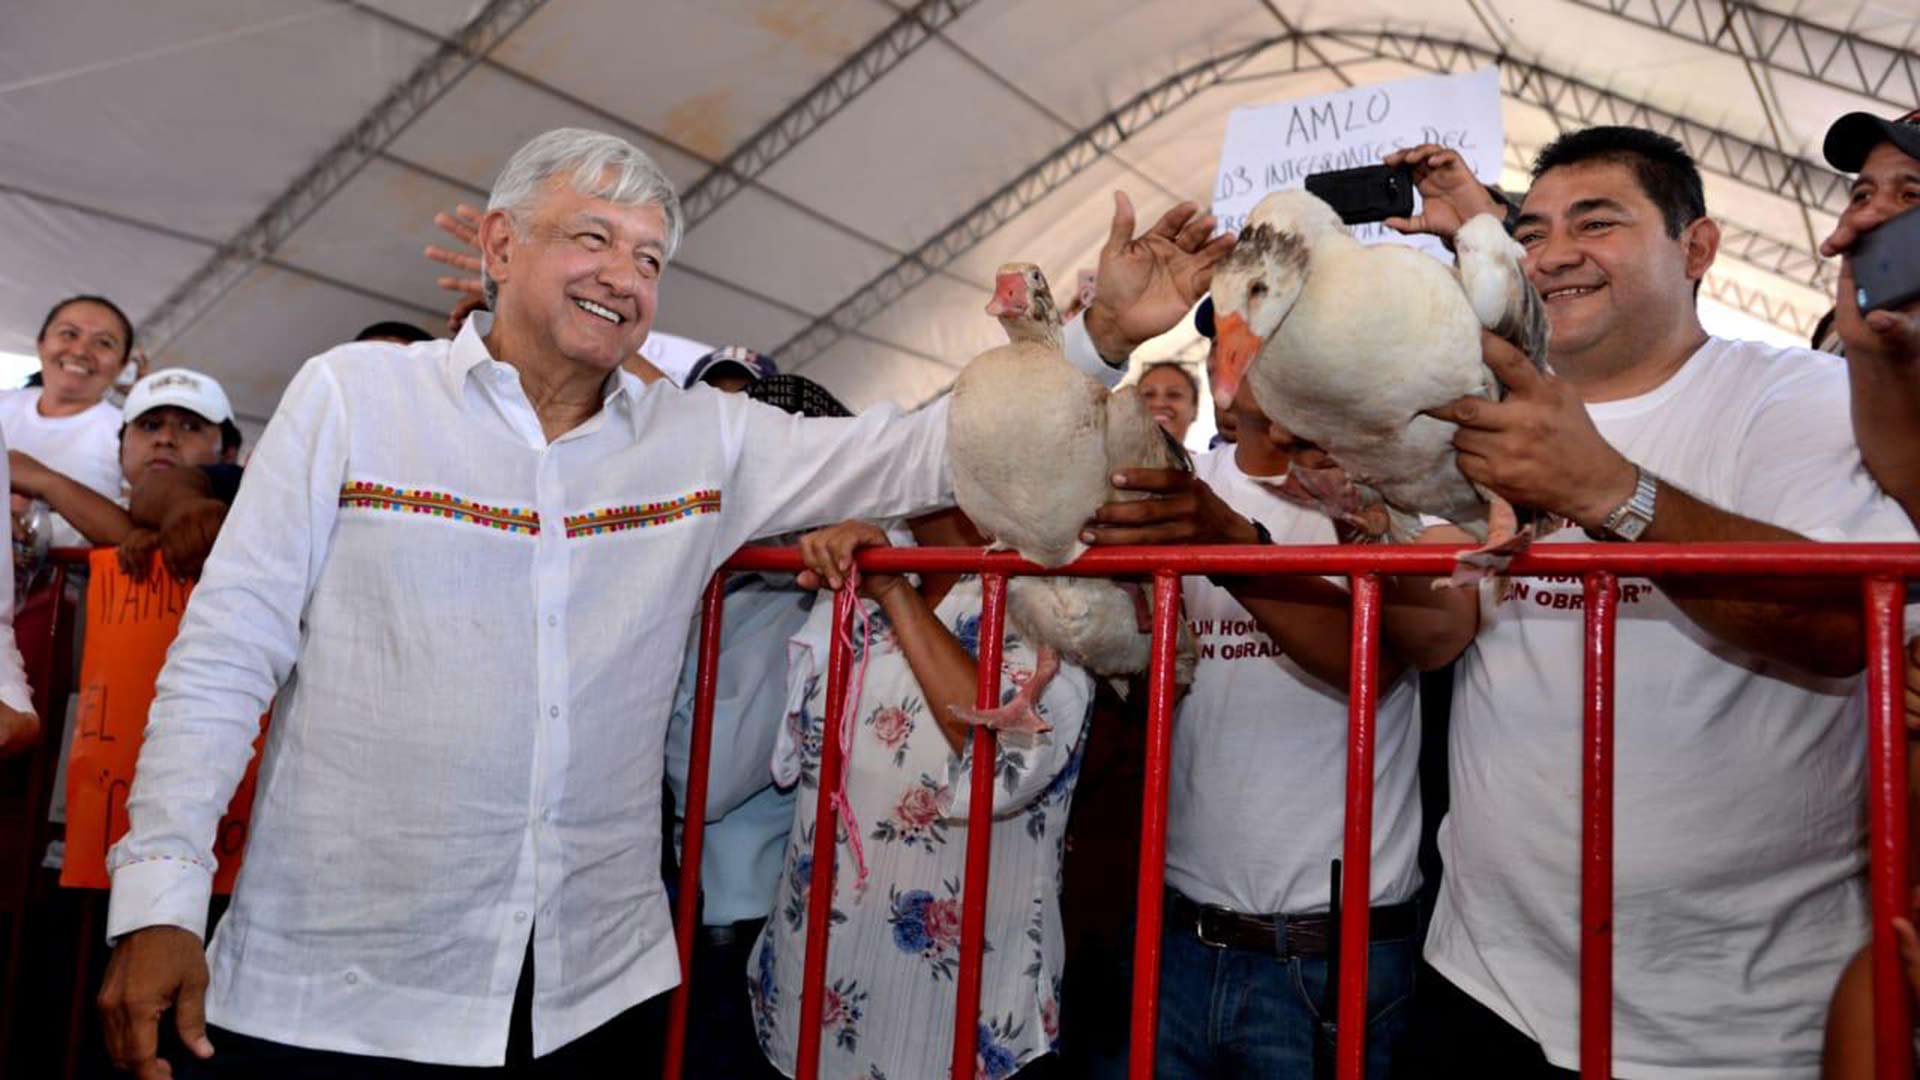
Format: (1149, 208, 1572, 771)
(1213, 192, 1548, 582)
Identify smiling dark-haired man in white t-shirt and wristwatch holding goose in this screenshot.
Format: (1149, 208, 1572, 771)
(1388, 127, 1914, 1076)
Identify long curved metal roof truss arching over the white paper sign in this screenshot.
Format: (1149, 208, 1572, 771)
(774, 31, 1847, 371)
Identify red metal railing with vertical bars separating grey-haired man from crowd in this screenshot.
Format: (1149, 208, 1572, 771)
(664, 544, 1920, 1080)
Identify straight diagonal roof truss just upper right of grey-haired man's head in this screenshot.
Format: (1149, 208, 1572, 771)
(680, 0, 979, 233)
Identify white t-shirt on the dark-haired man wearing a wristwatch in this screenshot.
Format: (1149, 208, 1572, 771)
(1427, 338, 1914, 1078)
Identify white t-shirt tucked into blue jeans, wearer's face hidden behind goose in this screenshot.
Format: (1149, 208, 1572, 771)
(1167, 446, 1421, 915)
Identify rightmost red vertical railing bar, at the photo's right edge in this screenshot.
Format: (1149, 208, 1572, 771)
(1864, 577, 1914, 1080)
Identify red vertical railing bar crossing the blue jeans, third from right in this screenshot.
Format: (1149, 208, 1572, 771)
(1334, 575, 1380, 1080)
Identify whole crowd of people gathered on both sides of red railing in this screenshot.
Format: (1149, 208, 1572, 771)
(0, 100, 1920, 1080)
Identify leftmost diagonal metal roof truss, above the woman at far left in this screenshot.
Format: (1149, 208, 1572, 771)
(140, 0, 547, 354)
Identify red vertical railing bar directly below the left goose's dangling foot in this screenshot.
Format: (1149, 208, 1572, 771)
(952, 575, 1006, 1080)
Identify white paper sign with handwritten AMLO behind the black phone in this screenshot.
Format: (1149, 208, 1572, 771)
(1213, 67, 1507, 261)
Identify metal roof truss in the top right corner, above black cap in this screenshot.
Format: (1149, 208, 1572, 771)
(1569, 0, 1920, 111)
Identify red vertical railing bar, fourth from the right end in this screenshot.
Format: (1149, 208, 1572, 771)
(1127, 571, 1181, 1080)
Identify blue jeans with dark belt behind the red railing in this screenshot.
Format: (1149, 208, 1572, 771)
(1154, 903, 1421, 1080)
